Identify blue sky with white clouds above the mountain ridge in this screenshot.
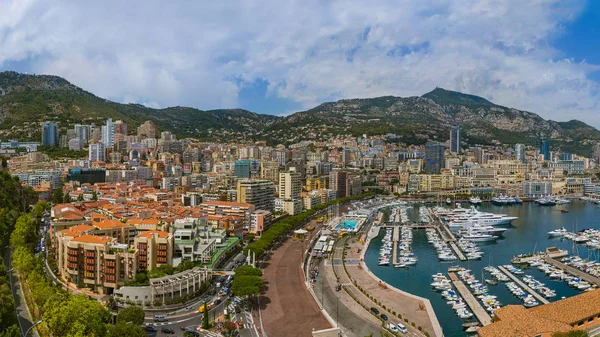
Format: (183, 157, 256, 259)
(0, 0, 600, 128)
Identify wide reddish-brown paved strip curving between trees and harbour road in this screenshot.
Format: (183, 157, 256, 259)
(260, 222, 332, 337)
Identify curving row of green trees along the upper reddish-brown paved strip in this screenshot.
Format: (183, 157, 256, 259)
(244, 192, 374, 256)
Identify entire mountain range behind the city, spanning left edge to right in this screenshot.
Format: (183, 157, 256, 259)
(0, 72, 600, 154)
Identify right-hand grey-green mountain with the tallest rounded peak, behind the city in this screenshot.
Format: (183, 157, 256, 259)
(265, 88, 600, 154)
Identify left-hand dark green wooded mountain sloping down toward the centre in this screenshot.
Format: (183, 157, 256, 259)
(0, 71, 278, 141)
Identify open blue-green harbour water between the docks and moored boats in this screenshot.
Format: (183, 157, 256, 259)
(365, 201, 600, 337)
